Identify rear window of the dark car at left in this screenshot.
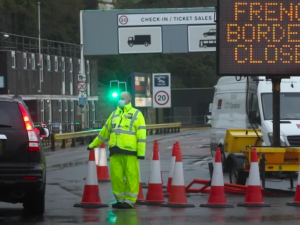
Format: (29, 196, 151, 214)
(0, 101, 24, 130)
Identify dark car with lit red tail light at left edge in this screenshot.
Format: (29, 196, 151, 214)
(0, 96, 49, 215)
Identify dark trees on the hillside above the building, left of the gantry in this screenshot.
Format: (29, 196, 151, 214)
(0, 0, 98, 43)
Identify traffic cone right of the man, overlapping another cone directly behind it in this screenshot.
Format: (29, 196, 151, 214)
(160, 145, 195, 208)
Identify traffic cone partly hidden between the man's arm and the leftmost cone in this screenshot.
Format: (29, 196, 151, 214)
(96, 142, 110, 182)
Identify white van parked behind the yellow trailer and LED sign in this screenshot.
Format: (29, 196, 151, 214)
(211, 76, 300, 183)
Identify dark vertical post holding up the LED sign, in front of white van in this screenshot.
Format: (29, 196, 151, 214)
(272, 77, 281, 147)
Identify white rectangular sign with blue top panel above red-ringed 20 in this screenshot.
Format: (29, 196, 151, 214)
(152, 73, 171, 108)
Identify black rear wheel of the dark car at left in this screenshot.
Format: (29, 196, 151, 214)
(23, 186, 46, 216)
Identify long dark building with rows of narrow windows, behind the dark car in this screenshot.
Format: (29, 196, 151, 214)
(0, 33, 98, 128)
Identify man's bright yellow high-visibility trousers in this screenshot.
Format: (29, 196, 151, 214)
(110, 154, 140, 205)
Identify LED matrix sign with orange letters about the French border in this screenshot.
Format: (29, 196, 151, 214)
(217, 0, 300, 75)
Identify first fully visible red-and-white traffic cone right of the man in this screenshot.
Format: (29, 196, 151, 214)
(139, 140, 165, 205)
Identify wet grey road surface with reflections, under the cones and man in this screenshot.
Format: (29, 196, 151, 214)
(0, 130, 300, 225)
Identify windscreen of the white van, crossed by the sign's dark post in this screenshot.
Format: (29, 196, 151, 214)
(261, 93, 300, 120)
